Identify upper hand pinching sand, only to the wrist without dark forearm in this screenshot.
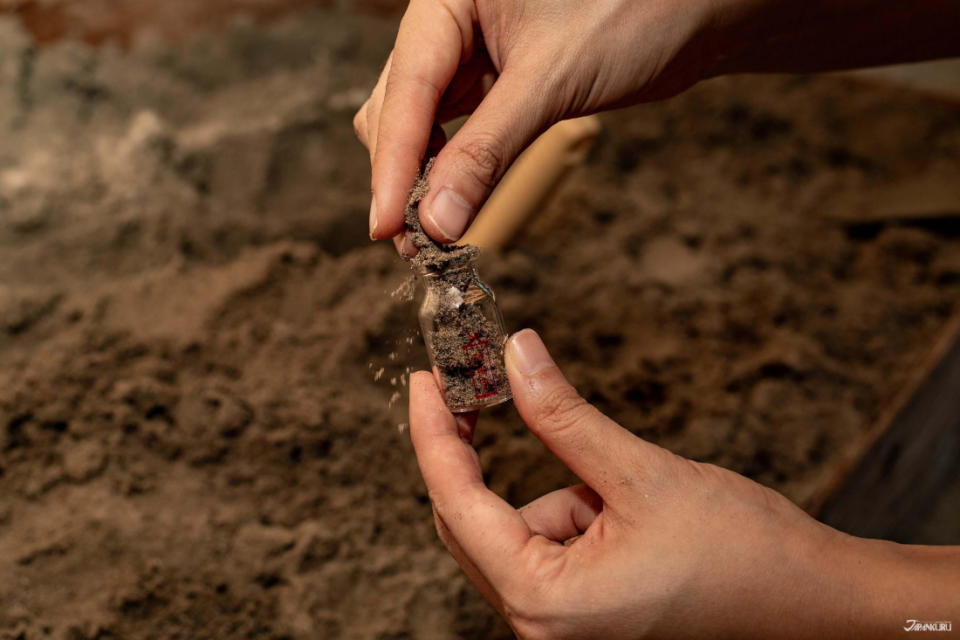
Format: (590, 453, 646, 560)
(354, 0, 713, 248)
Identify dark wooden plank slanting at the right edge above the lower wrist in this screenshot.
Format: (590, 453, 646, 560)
(811, 311, 960, 541)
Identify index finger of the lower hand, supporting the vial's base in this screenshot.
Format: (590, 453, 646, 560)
(410, 371, 532, 585)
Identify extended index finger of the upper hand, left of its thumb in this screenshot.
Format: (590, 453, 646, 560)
(371, 0, 473, 239)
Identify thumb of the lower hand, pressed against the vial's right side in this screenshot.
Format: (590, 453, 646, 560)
(505, 329, 664, 499)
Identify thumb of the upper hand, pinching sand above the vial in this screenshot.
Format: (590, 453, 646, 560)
(420, 71, 547, 243)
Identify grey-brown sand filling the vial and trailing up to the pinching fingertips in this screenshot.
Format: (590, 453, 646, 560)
(405, 160, 512, 413)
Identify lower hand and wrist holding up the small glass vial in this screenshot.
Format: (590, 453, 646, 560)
(410, 330, 960, 640)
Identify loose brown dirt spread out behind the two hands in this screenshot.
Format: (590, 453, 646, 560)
(0, 6, 960, 640)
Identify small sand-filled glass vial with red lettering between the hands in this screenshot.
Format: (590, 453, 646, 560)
(419, 259, 512, 413)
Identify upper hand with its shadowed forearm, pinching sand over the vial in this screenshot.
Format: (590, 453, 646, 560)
(354, 0, 960, 251)
